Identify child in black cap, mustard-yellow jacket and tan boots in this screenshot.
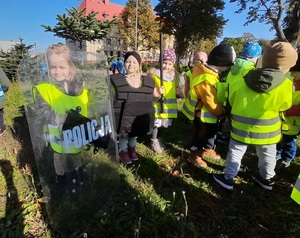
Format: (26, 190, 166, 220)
(182, 44, 236, 167)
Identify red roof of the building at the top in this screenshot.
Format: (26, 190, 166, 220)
(78, 0, 124, 21)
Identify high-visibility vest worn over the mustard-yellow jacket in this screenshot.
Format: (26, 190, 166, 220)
(181, 73, 219, 123)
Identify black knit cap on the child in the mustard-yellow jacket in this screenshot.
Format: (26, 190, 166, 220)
(207, 44, 236, 66)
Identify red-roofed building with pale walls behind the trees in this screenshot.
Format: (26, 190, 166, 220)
(67, 0, 126, 57)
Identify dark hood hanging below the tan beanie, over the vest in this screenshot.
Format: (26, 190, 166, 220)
(244, 68, 286, 93)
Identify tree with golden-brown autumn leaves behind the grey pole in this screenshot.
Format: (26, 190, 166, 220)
(118, 0, 160, 50)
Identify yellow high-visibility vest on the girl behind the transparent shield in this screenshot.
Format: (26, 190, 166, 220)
(34, 83, 88, 154)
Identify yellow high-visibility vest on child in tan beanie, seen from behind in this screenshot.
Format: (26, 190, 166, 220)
(228, 78, 293, 145)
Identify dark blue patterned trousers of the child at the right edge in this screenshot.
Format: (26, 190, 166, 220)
(276, 134, 297, 163)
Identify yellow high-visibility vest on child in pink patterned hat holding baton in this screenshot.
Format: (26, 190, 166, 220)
(152, 75, 178, 119)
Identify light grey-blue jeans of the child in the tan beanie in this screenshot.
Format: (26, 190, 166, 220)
(224, 139, 276, 179)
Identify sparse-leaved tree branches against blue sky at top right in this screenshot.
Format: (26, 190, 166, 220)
(230, 0, 290, 41)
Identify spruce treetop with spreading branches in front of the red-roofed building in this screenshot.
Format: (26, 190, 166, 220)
(41, 7, 115, 49)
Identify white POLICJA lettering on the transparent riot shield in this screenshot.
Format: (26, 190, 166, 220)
(63, 115, 111, 153)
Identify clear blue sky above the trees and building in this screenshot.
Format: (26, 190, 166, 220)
(0, 0, 275, 49)
